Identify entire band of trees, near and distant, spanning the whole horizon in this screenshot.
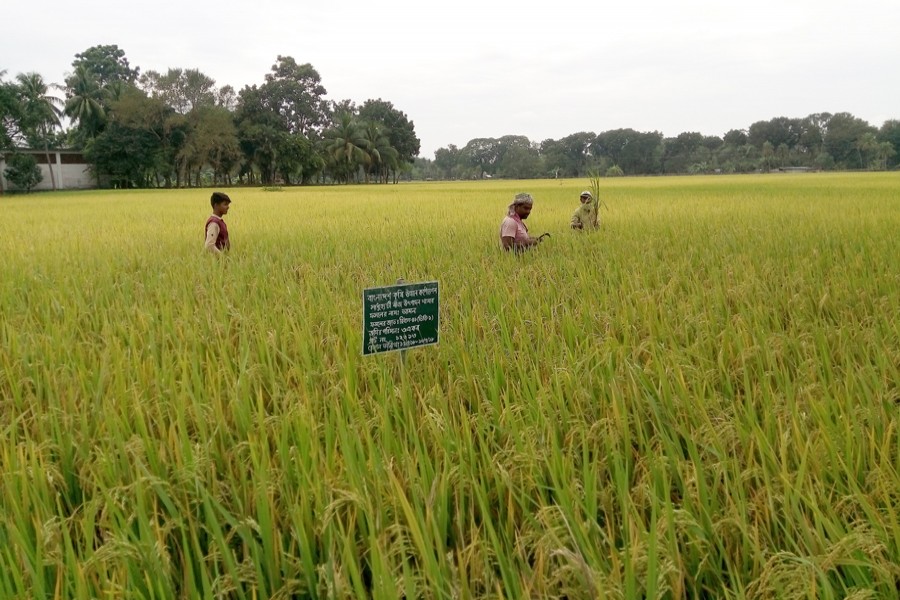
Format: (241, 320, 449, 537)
(0, 45, 900, 188)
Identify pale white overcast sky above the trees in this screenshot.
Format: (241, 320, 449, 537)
(0, 0, 900, 158)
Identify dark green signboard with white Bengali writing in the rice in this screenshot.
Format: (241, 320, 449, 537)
(363, 281, 440, 355)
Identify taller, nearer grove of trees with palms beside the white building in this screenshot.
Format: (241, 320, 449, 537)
(0, 45, 420, 188)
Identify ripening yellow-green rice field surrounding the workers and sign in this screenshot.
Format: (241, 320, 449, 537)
(0, 174, 900, 600)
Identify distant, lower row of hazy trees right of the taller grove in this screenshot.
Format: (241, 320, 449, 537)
(417, 112, 900, 179)
